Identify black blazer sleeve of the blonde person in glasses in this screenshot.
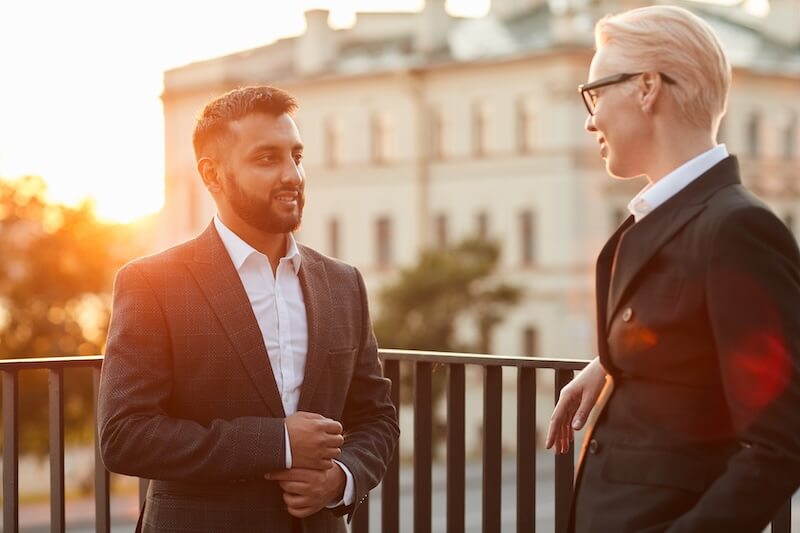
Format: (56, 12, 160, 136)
(668, 207, 800, 532)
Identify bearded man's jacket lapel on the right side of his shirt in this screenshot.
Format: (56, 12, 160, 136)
(297, 246, 333, 411)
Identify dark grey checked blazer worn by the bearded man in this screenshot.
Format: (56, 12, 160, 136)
(98, 224, 399, 532)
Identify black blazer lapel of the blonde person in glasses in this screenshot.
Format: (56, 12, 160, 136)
(605, 156, 741, 328)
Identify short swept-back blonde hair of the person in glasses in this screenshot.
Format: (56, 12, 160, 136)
(594, 6, 731, 134)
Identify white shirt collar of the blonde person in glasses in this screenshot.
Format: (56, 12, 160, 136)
(628, 144, 728, 222)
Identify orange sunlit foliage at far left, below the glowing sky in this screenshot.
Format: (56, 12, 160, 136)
(0, 177, 140, 452)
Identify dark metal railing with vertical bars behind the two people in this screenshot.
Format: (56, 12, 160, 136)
(0, 350, 791, 533)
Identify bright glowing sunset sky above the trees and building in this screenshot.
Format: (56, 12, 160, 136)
(0, 0, 759, 222)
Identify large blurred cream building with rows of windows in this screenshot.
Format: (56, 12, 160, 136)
(160, 0, 800, 366)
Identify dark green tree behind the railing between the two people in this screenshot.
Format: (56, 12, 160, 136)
(375, 239, 522, 401)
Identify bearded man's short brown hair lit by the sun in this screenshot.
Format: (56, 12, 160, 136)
(192, 85, 297, 160)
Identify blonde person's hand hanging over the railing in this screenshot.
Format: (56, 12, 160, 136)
(544, 358, 606, 453)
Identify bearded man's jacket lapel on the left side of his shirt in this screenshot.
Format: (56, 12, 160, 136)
(188, 223, 286, 417)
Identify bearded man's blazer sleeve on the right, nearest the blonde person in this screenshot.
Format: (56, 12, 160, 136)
(334, 269, 400, 517)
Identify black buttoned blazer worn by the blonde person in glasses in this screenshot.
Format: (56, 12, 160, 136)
(573, 157, 800, 533)
